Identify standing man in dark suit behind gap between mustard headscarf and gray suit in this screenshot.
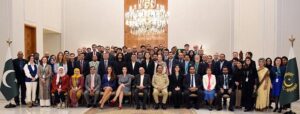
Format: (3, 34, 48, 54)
(76, 53, 90, 77)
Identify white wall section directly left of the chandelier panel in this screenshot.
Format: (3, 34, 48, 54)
(62, 0, 124, 51)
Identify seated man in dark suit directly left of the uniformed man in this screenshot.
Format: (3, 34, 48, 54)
(134, 67, 150, 110)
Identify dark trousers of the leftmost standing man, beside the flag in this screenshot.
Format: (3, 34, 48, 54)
(14, 81, 26, 104)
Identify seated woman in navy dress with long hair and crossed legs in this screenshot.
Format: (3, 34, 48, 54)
(99, 66, 117, 109)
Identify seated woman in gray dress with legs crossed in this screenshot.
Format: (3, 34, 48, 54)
(111, 67, 133, 109)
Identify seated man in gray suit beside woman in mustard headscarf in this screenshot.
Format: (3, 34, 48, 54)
(84, 66, 101, 108)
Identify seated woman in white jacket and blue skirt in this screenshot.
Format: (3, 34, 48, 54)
(202, 68, 216, 111)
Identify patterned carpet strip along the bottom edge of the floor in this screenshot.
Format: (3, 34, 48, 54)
(85, 108, 196, 114)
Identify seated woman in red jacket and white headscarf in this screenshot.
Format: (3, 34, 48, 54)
(51, 67, 69, 108)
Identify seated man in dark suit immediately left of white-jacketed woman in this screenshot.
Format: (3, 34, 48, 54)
(183, 66, 203, 109)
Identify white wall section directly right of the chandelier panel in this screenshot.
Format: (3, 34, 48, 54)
(168, 0, 232, 54)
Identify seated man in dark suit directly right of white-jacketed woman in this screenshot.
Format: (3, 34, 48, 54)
(216, 67, 235, 111)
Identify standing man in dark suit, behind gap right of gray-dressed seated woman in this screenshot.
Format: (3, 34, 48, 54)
(126, 54, 141, 76)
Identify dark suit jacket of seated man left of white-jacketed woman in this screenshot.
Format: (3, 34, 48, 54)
(183, 74, 203, 89)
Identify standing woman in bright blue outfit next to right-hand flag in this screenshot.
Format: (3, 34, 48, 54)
(271, 57, 285, 113)
